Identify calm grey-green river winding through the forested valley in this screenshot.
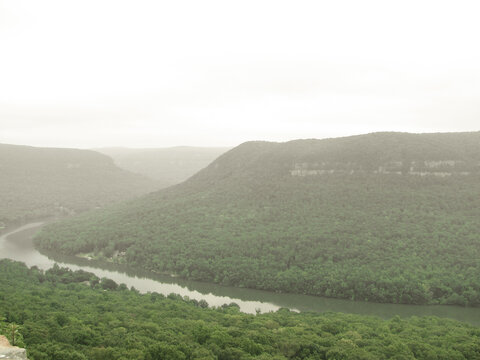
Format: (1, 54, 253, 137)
(0, 222, 480, 326)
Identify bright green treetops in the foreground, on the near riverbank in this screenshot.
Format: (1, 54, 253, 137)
(0, 260, 480, 360)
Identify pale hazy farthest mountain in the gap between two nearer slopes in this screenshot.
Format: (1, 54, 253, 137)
(95, 146, 230, 187)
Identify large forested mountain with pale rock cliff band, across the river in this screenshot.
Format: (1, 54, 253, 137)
(36, 132, 480, 306)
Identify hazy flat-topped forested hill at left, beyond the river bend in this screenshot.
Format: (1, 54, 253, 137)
(0, 144, 158, 225)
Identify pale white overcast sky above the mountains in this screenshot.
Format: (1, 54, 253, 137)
(0, 0, 480, 148)
